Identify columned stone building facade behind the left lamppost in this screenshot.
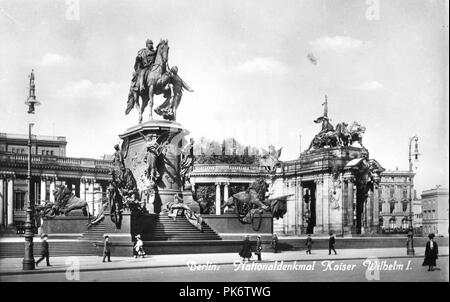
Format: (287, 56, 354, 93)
(0, 133, 111, 230)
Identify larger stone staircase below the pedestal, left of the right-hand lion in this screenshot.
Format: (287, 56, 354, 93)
(143, 214, 222, 241)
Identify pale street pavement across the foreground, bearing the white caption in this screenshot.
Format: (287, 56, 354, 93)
(0, 247, 449, 282)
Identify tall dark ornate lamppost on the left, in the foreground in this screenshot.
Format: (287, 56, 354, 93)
(22, 70, 40, 270)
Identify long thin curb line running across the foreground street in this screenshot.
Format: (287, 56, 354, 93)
(0, 254, 449, 277)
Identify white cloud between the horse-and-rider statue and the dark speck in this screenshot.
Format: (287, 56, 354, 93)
(234, 57, 289, 75)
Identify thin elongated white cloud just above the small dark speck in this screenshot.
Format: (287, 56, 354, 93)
(308, 36, 371, 53)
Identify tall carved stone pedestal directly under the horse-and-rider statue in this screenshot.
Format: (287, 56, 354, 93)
(119, 120, 189, 213)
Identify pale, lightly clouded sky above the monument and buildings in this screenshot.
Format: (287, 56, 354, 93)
(0, 0, 449, 192)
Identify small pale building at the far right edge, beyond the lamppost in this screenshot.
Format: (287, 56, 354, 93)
(421, 186, 449, 236)
